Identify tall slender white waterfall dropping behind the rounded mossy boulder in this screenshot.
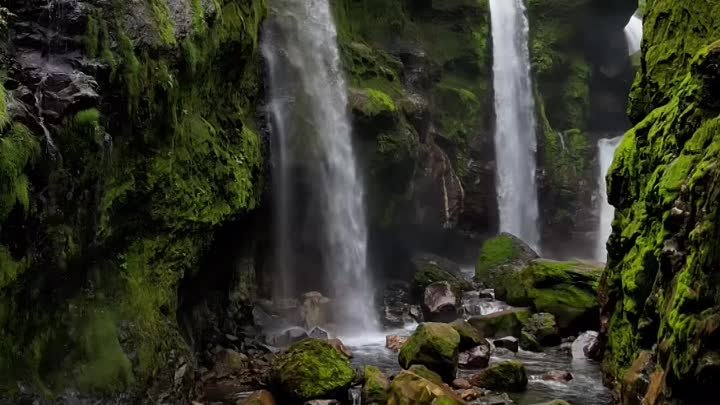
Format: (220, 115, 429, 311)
(490, 0, 540, 249)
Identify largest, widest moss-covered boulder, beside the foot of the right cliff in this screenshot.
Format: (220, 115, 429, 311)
(496, 259, 603, 335)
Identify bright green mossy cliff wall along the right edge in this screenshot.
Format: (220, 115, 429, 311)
(601, 0, 720, 405)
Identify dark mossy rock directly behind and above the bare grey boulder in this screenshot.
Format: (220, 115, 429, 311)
(412, 255, 472, 298)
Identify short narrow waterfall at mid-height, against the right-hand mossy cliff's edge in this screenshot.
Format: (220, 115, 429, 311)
(595, 136, 623, 263)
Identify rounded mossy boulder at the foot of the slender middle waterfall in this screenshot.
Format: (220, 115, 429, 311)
(475, 233, 538, 292)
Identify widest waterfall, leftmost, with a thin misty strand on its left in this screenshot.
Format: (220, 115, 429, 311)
(262, 0, 374, 332)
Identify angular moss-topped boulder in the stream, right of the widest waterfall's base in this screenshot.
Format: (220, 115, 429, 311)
(398, 323, 460, 382)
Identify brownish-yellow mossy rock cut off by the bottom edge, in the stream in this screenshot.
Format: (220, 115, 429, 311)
(387, 370, 464, 405)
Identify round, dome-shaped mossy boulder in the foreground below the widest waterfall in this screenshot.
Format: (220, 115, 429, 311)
(271, 339, 355, 401)
